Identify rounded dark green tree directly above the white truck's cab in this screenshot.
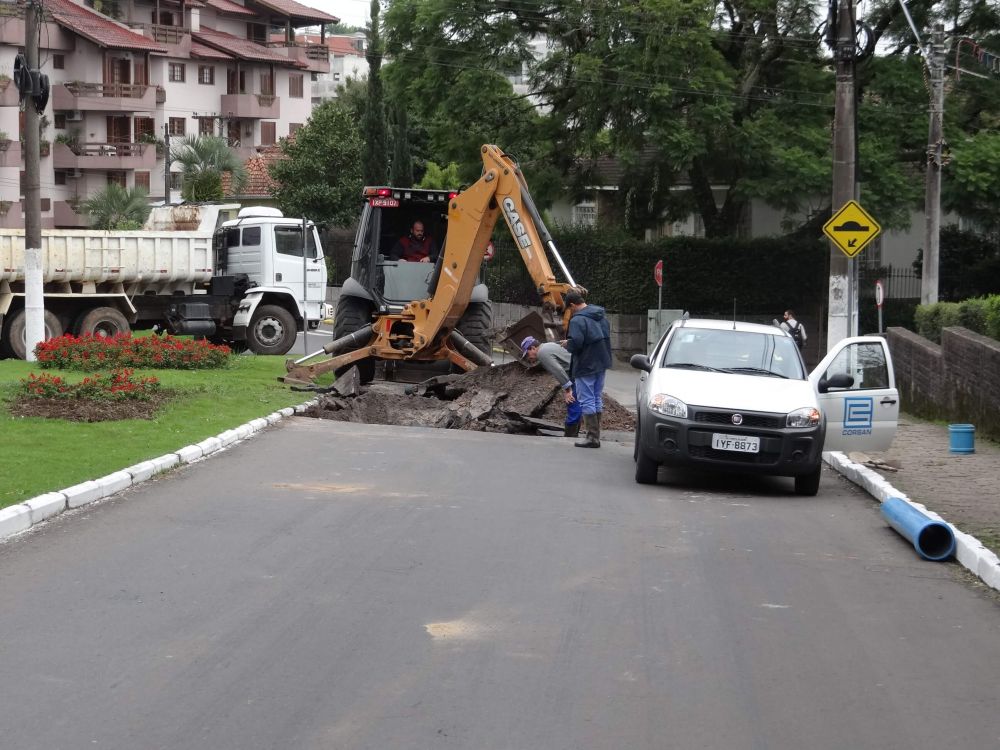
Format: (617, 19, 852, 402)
(270, 100, 364, 226)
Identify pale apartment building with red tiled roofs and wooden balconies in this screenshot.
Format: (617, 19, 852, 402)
(0, 0, 337, 228)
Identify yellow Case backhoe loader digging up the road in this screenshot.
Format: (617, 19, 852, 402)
(281, 145, 586, 385)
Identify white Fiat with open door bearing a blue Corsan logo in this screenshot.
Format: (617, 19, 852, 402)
(631, 319, 899, 495)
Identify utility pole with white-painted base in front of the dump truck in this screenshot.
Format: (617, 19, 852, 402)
(22, 0, 45, 362)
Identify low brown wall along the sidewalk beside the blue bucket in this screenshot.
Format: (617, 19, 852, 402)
(886, 327, 1000, 440)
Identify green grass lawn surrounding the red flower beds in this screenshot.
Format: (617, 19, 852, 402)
(0, 356, 310, 508)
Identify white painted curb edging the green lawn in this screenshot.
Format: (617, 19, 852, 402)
(0, 398, 318, 541)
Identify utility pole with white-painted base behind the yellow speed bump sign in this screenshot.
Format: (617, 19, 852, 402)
(826, 0, 857, 350)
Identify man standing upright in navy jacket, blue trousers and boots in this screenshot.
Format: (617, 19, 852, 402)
(565, 292, 611, 448)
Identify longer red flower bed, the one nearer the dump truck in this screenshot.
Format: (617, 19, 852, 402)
(35, 333, 232, 371)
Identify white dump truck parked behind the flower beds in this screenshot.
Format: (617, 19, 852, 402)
(0, 204, 332, 359)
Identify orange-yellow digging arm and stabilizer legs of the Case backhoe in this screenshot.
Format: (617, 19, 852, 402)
(282, 145, 579, 384)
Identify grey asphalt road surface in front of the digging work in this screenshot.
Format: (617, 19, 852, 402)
(0, 418, 1000, 750)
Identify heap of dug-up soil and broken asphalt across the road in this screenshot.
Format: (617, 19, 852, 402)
(305, 362, 635, 435)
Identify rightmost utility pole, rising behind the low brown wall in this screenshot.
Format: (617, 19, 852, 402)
(920, 24, 945, 305)
